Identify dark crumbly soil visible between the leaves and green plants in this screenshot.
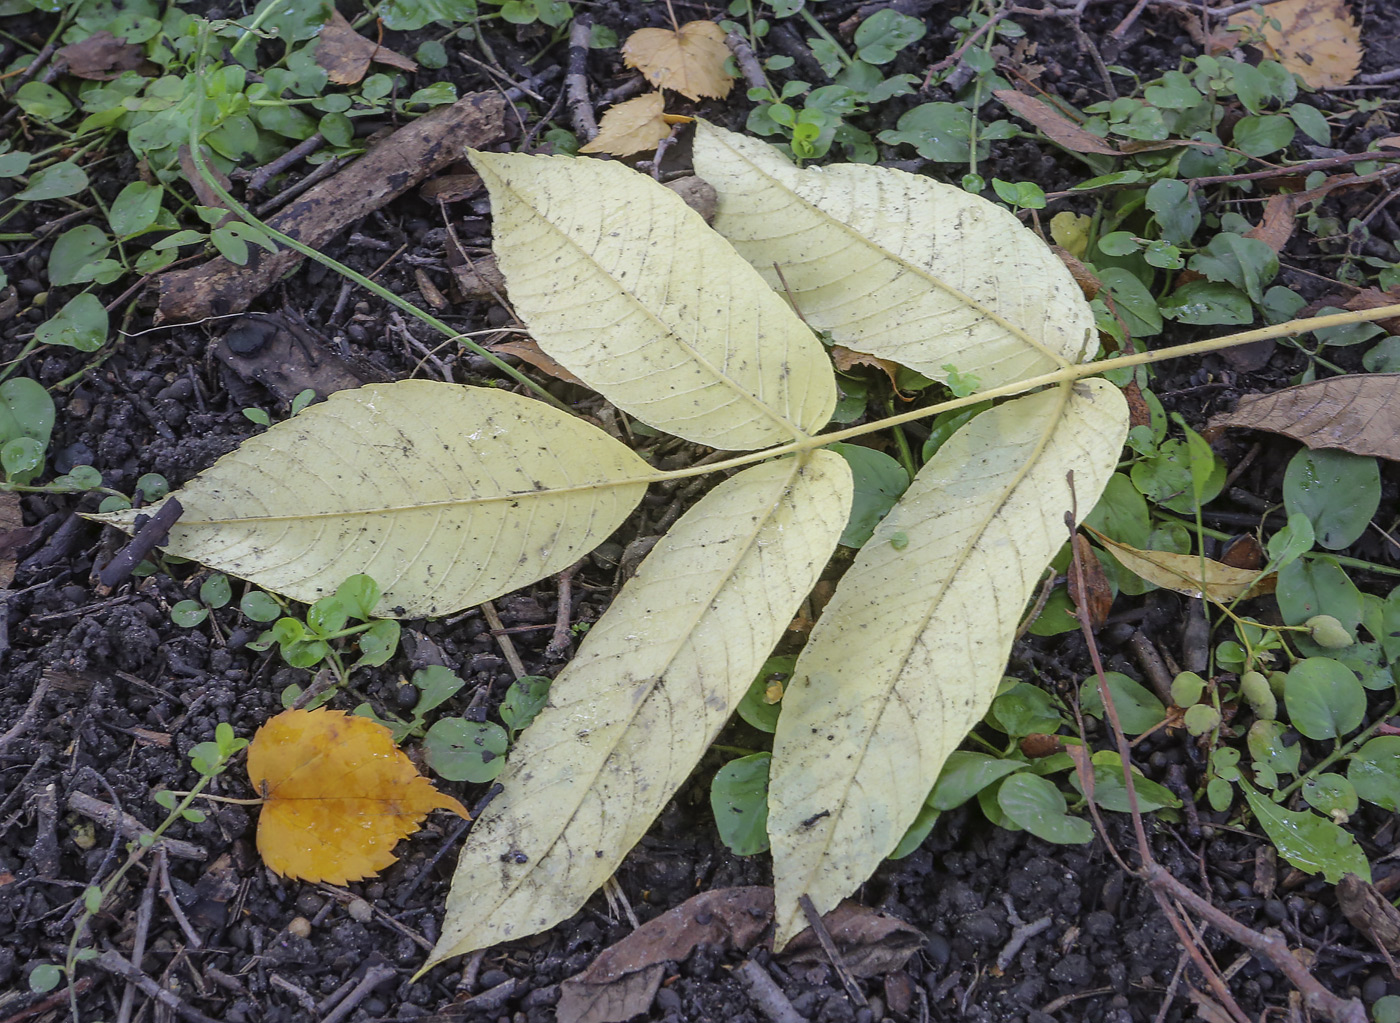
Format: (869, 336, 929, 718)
(0, 0, 1400, 1023)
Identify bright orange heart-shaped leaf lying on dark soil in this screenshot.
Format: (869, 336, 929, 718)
(248, 708, 470, 884)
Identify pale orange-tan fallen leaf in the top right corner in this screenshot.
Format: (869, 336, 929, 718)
(1229, 0, 1362, 90)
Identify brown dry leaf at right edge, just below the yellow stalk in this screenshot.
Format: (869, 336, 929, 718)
(1210, 374, 1400, 462)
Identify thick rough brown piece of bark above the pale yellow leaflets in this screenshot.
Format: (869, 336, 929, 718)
(155, 92, 505, 323)
